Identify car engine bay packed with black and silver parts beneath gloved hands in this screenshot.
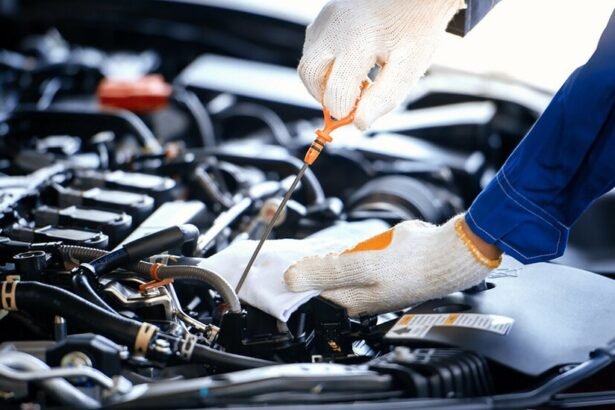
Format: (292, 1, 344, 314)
(0, 1, 615, 409)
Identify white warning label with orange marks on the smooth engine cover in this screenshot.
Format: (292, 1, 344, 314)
(385, 313, 515, 339)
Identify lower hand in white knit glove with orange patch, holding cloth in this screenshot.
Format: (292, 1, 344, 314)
(284, 216, 500, 316)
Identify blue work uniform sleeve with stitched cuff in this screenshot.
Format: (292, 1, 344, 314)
(466, 13, 615, 263)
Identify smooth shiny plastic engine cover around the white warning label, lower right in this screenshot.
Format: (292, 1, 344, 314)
(387, 258, 615, 376)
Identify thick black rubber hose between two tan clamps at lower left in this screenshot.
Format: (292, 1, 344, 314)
(15, 281, 141, 349)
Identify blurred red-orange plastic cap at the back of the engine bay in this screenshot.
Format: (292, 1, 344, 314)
(96, 74, 173, 113)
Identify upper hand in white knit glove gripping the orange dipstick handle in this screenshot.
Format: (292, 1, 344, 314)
(299, 0, 464, 129)
